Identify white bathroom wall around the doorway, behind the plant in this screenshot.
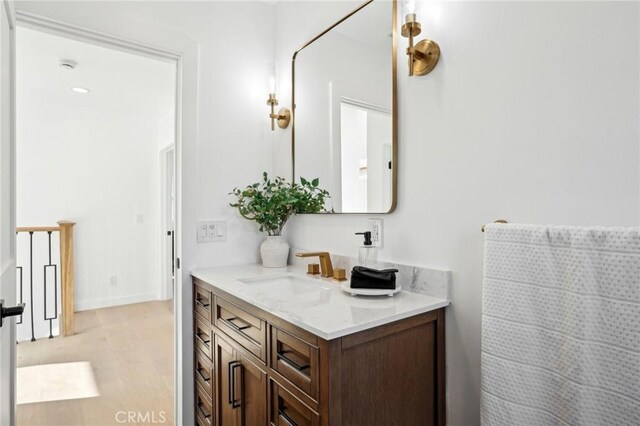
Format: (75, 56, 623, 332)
(17, 1, 276, 424)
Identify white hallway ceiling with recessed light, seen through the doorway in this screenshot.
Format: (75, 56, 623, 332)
(16, 27, 176, 117)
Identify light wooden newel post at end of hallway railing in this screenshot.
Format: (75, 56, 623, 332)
(58, 220, 75, 336)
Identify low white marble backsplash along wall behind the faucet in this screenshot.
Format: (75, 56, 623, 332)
(289, 247, 451, 300)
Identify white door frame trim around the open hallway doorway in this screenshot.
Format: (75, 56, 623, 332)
(13, 11, 188, 425)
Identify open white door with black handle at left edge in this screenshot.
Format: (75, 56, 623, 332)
(0, 0, 16, 426)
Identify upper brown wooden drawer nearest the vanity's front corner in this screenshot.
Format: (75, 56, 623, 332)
(269, 326, 318, 401)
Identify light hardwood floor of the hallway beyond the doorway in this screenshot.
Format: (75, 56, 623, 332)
(17, 301, 173, 426)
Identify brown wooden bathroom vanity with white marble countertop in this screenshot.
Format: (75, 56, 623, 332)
(192, 265, 449, 426)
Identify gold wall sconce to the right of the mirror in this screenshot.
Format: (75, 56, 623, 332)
(400, 0, 440, 76)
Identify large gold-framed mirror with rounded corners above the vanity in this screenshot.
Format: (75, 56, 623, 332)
(291, 0, 398, 214)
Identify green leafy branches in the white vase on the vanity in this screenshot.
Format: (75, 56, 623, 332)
(229, 172, 330, 235)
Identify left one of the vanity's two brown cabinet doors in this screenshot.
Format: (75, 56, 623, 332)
(213, 334, 241, 426)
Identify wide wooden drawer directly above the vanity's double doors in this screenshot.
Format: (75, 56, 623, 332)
(213, 296, 267, 361)
